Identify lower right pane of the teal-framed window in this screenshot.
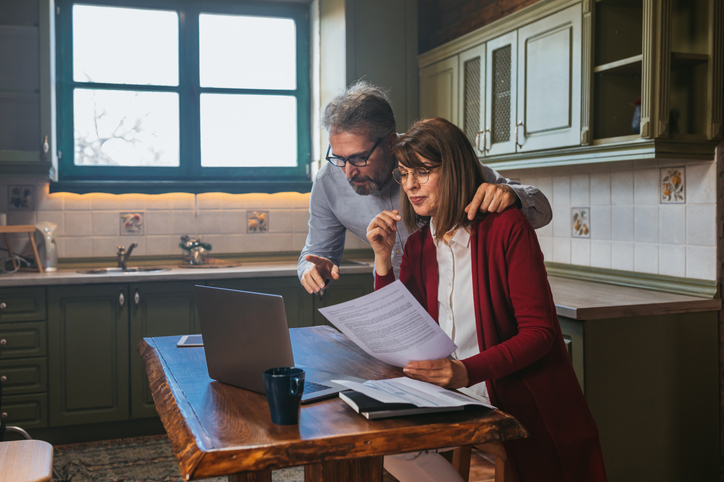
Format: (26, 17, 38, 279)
(201, 94, 297, 167)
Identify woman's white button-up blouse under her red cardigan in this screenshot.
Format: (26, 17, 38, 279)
(430, 222, 490, 403)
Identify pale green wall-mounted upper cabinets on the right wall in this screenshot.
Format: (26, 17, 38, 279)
(418, 0, 724, 166)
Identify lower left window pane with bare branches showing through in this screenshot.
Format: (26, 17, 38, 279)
(73, 89, 179, 167)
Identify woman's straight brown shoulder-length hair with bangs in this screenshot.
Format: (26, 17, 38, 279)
(393, 117, 484, 239)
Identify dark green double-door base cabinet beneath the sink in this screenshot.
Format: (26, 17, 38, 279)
(48, 281, 198, 426)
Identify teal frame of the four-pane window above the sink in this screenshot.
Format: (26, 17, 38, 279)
(51, 0, 311, 192)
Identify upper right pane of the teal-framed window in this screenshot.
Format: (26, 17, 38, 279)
(199, 14, 297, 89)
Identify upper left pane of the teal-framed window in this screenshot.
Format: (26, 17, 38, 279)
(73, 5, 178, 85)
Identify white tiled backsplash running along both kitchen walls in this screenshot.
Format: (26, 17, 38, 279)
(0, 150, 721, 280)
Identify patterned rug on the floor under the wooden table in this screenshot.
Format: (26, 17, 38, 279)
(53, 435, 304, 482)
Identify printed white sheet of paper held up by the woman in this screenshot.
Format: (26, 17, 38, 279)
(319, 280, 457, 367)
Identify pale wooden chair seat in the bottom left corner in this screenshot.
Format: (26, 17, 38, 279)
(0, 440, 53, 482)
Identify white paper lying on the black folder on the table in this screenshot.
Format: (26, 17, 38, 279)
(333, 377, 495, 408)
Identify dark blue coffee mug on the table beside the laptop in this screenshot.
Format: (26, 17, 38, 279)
(264, 367, 304, 425)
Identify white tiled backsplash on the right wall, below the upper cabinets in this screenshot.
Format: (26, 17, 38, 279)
(503, 156, 718, 280)
